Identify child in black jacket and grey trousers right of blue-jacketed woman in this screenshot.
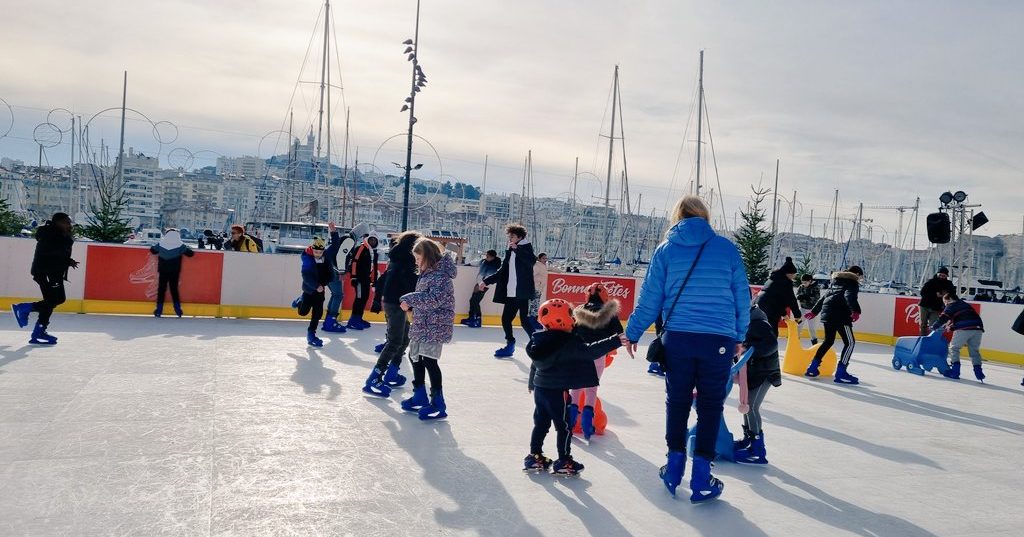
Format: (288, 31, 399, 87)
(732, 304, 782, 464)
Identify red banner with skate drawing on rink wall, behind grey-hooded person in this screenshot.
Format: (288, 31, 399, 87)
(85, 244, 224, 304)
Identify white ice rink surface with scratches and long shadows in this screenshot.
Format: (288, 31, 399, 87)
(0, 314, 1024, 537)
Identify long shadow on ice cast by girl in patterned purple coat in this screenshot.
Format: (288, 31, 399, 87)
(380, 405, 542, 537)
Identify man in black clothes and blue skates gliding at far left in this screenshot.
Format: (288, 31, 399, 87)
(11, 212, 78, 345)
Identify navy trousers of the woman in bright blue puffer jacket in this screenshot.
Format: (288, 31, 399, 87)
(662, 330, 736, 460)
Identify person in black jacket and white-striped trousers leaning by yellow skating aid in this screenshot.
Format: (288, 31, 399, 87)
(804, 264, 864, 384)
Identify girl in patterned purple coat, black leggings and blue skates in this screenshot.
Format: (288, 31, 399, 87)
(399, 237, 456, 420)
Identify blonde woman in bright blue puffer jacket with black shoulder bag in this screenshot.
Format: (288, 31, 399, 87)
(626, 196, 751, 502)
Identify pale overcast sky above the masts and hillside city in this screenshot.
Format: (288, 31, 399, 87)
(0, 0, 1024, 238)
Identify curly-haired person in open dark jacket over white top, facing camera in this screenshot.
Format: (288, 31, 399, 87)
(476, 223, 537, 358)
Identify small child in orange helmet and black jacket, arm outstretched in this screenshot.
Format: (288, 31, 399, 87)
(523, 298, 626, 476)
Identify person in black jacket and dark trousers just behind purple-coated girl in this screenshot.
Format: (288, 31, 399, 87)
(362, 232, 423, 398)
